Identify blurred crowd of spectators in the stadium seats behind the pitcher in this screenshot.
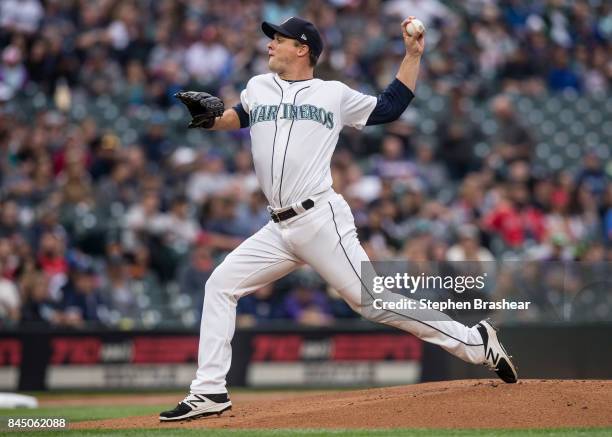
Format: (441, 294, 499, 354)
(0, 0, 612, 329)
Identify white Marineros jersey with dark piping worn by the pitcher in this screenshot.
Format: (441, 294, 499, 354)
(240, 73, 376, 208)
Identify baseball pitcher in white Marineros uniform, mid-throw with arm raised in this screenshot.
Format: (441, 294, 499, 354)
(159, 17, 517, 421)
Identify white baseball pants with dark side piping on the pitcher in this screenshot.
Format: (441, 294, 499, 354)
(191, 190, 485, 394)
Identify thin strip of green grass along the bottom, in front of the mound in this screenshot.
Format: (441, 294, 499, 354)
(1, 428, 612, 437)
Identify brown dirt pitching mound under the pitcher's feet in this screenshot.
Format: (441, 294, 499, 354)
(71, 380, 612, 429)
